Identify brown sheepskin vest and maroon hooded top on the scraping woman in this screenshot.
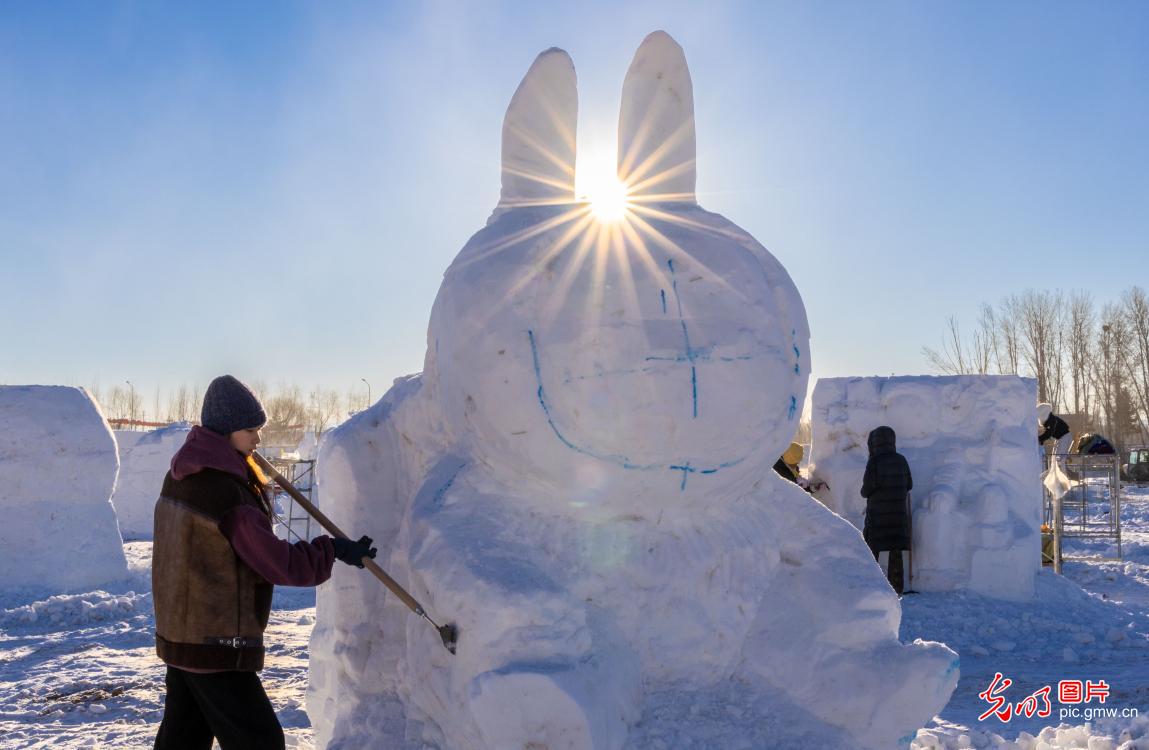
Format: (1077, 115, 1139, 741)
(152, 427, 334, 672)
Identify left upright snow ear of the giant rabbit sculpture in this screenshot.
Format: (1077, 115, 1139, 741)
(496, 47, 578, 211)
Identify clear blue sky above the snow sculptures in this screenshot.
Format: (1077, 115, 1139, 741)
(0, 0, 1149, 397)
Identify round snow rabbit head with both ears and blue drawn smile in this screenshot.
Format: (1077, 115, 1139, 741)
(425, 32, 810, 502)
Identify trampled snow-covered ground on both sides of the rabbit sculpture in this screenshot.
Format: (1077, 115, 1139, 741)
(0, 487, 1149, 750)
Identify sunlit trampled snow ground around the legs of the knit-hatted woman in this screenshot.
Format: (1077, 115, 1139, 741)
(0, 542, 315, 750)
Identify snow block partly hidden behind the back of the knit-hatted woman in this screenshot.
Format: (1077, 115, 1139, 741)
(111, 423, 192, 540)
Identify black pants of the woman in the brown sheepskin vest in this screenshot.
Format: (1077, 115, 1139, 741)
(153, 666, 284, 750)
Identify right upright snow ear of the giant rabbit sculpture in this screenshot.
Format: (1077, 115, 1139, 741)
(618, 31, 696, 203)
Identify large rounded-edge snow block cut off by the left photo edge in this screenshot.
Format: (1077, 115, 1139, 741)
(0, 386, 128, 593)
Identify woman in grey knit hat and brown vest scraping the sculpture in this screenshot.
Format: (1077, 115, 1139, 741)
(152, 376, 376, 750)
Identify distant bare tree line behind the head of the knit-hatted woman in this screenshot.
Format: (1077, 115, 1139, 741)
(88, 381, 370, 446)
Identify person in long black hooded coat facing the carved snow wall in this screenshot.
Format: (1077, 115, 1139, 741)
(862, 425, 913, 594)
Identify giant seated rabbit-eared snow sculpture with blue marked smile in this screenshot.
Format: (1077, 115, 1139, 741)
(308, 32, 957, 750)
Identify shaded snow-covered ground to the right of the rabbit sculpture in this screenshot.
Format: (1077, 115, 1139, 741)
(902, 477, 1149, 750)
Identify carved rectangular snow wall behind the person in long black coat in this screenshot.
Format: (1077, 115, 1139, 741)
(811, 376, 1042, 600)
